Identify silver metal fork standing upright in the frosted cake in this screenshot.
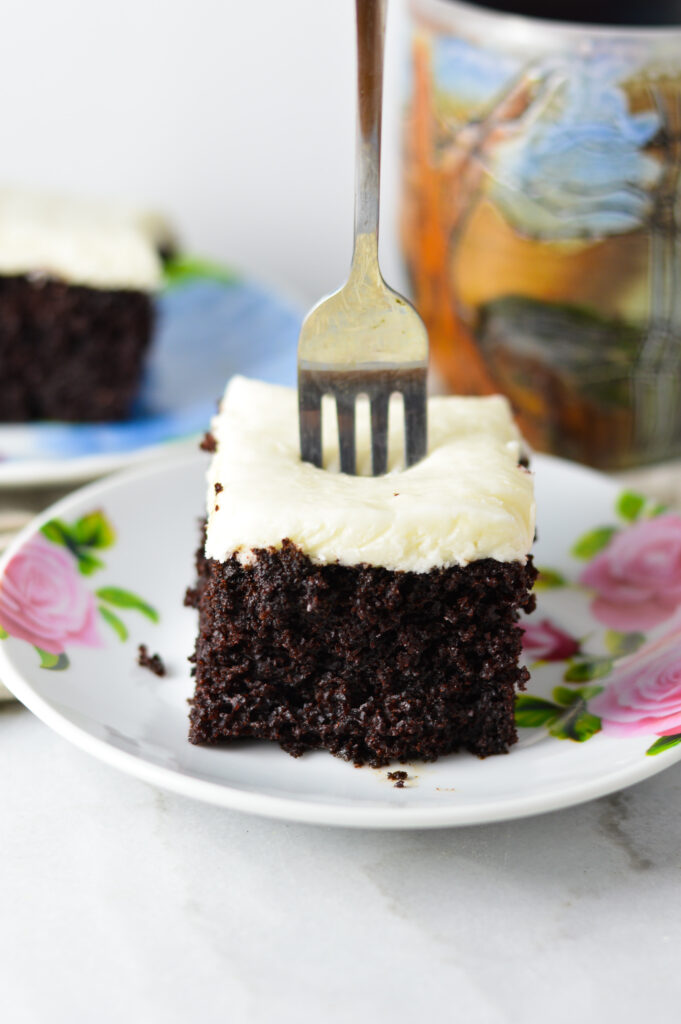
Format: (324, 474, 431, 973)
(298, 0, 428, 476)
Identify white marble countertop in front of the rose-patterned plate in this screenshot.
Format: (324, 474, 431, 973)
(0, 705, 681, 1024)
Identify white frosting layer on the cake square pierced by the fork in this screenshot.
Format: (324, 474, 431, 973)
(206, 377, 535, 572)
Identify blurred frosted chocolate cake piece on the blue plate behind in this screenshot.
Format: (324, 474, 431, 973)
(0, 188, 167, 422)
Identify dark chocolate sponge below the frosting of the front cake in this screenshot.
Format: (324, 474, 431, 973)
(187, 540, 537, 770)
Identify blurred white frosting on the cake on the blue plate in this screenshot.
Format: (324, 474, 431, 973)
(0, 188, 162, 292)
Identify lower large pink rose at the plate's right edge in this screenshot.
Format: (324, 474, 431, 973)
(589, 643, 681, 736)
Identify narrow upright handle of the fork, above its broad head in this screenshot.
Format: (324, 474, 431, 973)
(354, 0, 387, 245)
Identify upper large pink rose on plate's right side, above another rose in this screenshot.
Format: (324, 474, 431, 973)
(580, 514, 681, 632)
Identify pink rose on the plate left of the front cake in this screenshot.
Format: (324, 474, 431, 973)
(0, 534, 101, 654)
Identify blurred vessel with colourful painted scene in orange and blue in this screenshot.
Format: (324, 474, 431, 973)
(400, 0, 681, 469)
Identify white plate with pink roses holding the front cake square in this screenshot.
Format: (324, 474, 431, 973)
(0, 456, 681, 828)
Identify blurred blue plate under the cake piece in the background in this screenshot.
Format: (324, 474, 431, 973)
(0, 264, 301, 486)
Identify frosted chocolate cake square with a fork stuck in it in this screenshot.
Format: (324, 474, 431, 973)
(187, 378, 536, 766)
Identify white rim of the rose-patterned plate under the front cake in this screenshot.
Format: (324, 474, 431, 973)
(0, 452, 681, 829)
